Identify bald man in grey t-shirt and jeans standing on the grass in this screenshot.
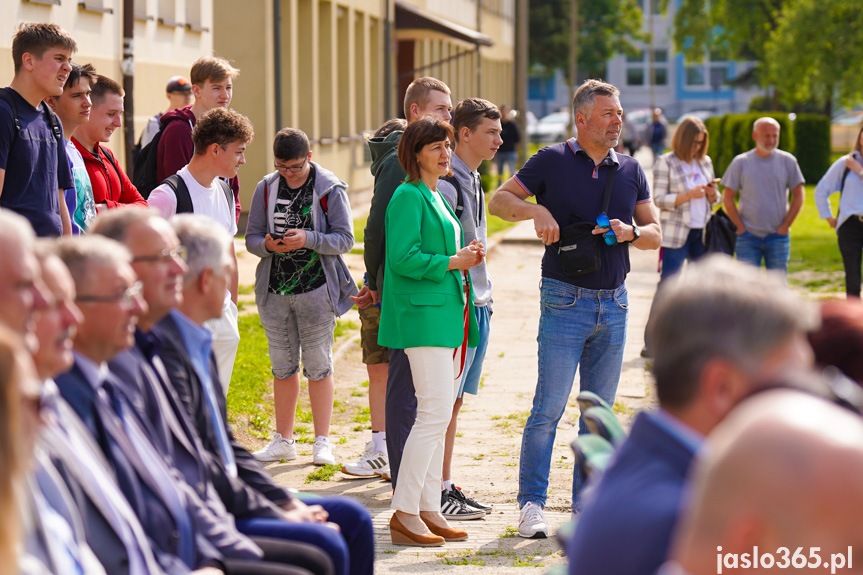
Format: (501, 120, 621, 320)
(722, 118, 805, 274)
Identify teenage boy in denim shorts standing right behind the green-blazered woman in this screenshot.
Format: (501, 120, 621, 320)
(438, 98, 503, 518)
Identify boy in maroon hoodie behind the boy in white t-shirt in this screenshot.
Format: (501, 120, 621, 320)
(156, 56, 241, 222)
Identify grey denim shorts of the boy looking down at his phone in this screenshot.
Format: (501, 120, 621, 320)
(258, 284, 336, 381)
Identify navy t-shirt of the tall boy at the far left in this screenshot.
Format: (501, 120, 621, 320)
(0, 88, 75, 236)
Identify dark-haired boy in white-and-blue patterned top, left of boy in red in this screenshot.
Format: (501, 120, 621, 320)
(45, 63, 96, 234)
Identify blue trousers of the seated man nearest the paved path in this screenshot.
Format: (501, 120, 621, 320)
(237, 497, 375, 575)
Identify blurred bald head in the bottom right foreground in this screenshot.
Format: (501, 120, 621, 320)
(672, 390, 863, 575)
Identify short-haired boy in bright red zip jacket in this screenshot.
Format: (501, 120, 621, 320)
(72, 75, 147, 211)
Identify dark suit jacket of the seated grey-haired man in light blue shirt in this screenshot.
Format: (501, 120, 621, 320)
(159, 315, 291, 508)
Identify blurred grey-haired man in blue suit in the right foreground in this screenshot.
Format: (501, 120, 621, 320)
(567, 255, 816, 575)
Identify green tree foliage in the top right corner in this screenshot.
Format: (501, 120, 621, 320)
(663, 0, 863, 114)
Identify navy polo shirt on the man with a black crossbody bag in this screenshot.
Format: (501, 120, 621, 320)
(515, 138, 650, 290)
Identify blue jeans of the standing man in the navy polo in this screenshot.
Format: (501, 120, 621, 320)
(518, 278, 629, 507)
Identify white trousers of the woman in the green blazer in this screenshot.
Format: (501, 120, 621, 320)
(390, 347, 460, 515)
